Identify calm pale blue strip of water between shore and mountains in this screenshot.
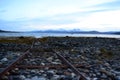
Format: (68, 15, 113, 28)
(0, 33, 120, 38)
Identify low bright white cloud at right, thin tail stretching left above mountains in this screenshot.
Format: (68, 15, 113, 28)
(29, 10, 120, 31)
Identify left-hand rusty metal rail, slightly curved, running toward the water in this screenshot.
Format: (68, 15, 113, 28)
(0, 41, 35, 80)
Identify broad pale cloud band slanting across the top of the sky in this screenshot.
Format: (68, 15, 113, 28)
(1, 0, 116, 20)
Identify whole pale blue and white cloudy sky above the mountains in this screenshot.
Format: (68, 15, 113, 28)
(0, 0, 120, 32)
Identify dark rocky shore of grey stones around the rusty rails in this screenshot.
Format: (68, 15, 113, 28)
(0, 36, 120, 80)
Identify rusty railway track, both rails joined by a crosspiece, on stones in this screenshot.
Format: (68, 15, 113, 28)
(0, 40, 87, 80)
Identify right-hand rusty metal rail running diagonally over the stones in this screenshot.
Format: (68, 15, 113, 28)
(53, 51, 87, 80)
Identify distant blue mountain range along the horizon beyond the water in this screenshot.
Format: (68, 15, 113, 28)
(0, 29, 120, 35)
